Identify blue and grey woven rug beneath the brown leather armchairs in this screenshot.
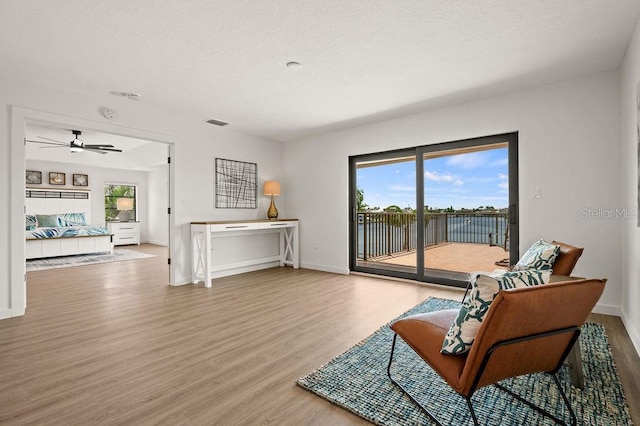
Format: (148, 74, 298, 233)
(297, 298, 632, 426)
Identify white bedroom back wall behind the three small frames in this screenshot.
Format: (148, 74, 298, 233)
(26, 160, 151, 238)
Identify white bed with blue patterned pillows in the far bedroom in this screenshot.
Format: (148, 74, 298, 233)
(25, 189, 113, 259)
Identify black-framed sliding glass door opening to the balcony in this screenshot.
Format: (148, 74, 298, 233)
(350, 133, 518, 287)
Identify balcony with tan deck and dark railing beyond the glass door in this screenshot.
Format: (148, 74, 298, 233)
(357, 212, 509, 273)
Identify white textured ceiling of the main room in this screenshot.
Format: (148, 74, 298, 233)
(0, 0, 640, 140)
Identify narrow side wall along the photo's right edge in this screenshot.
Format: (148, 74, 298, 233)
(620, 17, 640, 353)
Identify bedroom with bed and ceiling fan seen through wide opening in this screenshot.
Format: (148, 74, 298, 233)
(25, 124, 169, 270)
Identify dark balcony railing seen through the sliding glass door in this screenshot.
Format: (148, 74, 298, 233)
(357, 212, 509, 260)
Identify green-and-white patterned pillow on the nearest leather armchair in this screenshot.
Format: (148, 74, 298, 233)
(440, 269, 551, 355)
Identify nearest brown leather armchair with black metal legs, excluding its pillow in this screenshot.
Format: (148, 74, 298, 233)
(387, 279, 606, 425)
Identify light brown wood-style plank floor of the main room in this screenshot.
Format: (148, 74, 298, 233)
(0, 245, 640, 425)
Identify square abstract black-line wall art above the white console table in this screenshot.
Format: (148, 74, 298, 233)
(215, 158, 258, 209)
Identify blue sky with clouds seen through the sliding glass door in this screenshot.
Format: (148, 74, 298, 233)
(357, 148, 509, 209)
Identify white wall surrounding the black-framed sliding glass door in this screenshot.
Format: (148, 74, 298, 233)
(284, 72, 624, 315)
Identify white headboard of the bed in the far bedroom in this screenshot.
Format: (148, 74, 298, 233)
(25, 188, 93, 224)
